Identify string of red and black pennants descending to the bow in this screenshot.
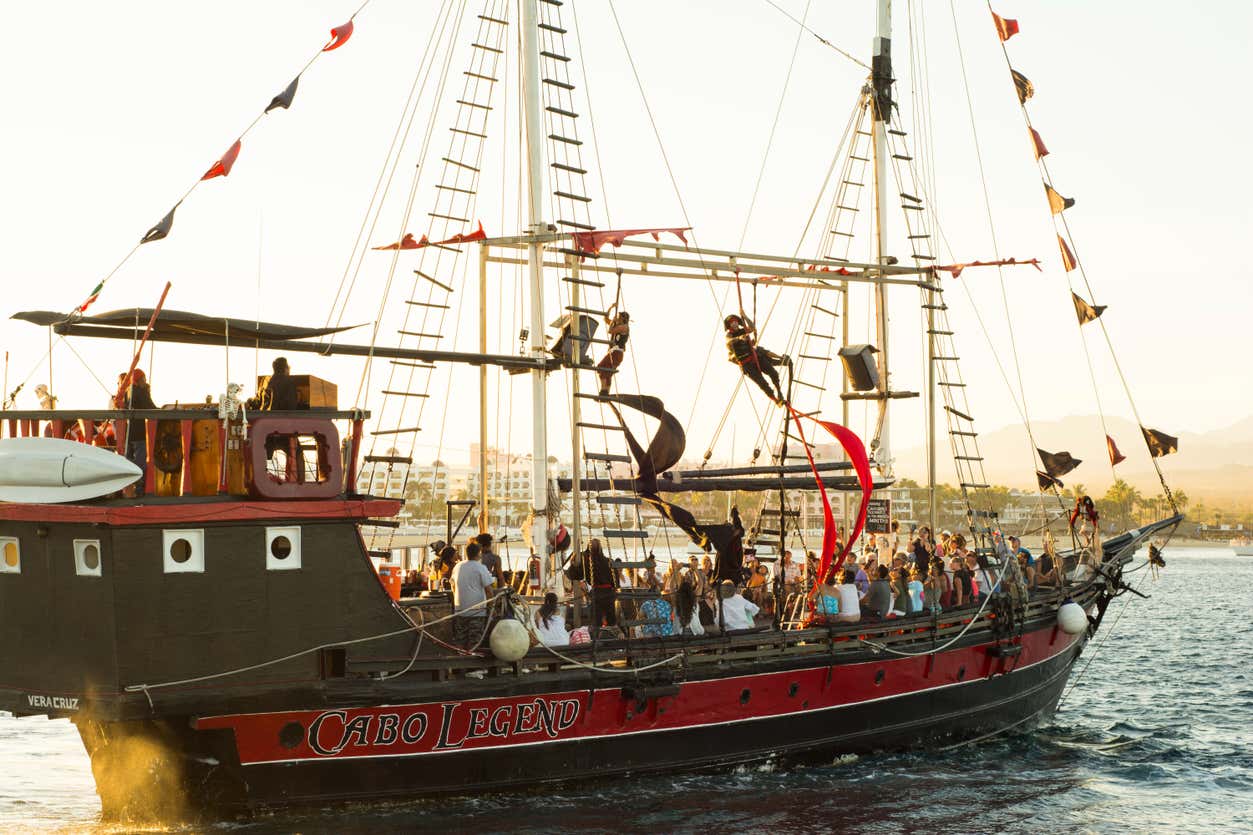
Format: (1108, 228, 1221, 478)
(987, 3, 1179, 473)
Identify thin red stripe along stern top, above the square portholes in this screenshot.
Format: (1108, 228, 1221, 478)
(0, 499, 400, 525)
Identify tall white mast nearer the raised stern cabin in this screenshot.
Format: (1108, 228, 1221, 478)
(519, 0, 548, 588)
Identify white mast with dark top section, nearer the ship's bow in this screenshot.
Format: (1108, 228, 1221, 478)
(871, 0, 892, 475)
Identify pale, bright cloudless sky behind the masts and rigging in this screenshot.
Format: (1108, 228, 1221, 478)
(0, 0, 1253, 476)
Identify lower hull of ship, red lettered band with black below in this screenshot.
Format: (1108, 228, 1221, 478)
(75, 616, 1086, 816)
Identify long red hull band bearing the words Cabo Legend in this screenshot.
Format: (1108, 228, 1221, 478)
(194, 627, 1075, 765)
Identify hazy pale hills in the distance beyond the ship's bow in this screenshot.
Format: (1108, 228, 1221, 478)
(896, 415, 1253, 504)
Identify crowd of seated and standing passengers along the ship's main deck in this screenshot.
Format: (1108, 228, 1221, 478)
(410, 522, 1093, 647)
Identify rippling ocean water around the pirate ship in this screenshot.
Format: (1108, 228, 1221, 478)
(0, 548, 1253, 835)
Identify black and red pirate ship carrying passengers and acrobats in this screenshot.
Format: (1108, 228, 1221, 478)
(0, 0, 1180, 816)
